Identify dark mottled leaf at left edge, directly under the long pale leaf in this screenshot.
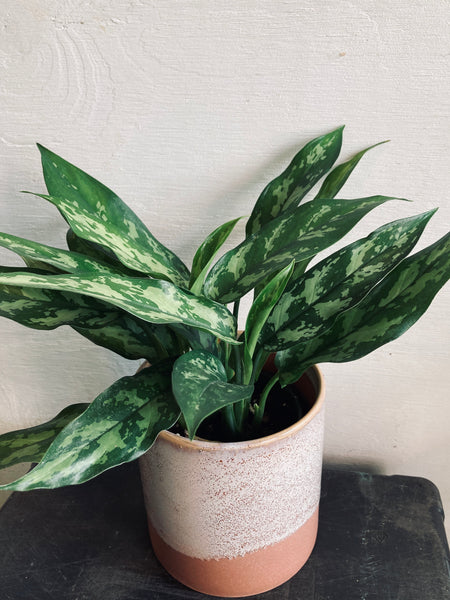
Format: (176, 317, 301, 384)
(0, 267, 119, 330)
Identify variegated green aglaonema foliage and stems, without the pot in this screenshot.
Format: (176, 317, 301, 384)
(0, 128, 450, 490)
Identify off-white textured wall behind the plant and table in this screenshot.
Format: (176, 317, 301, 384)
(0, 0, 450, 536)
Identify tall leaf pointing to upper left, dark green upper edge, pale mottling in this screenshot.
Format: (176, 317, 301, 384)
(36, 145, 189, 286)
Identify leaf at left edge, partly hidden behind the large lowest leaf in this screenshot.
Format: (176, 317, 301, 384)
(0, 403, 89, 469)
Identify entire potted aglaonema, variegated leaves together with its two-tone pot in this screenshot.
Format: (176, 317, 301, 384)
(0, 127, 450, 596)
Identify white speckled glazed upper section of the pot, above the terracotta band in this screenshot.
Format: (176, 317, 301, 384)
(140, 367, 324, 560)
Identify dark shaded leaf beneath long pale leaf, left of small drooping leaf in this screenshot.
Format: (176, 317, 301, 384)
(73, 313, 183, 364)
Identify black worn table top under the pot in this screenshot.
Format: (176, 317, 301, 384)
(0, 463, 450, 600)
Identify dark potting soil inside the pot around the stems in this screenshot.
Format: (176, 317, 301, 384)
(170, 373, 310, 442)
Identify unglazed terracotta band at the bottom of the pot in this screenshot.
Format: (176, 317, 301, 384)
(149, 508, 319, 598)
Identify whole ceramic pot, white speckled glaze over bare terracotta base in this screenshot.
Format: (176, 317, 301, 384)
(140, 367, 324, 597)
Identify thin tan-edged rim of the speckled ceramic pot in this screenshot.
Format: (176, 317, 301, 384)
(155, 365, 325, 452)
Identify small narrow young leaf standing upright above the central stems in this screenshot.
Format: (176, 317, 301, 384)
(245, 261, 295, 356)
